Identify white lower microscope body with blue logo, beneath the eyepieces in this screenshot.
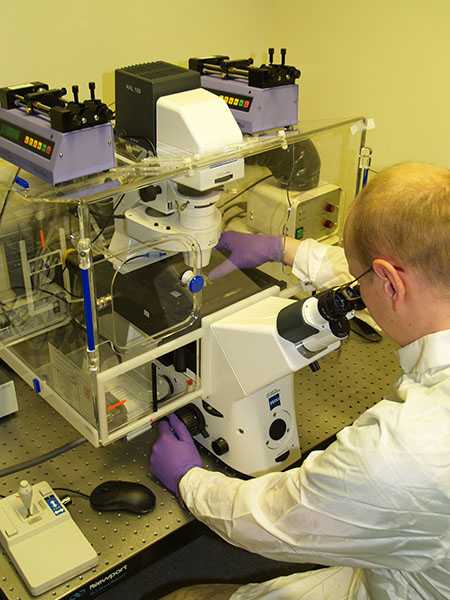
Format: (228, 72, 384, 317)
(191, 289, 348, 476)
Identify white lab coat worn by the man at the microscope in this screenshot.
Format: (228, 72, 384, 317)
(180, 243, 450, 600)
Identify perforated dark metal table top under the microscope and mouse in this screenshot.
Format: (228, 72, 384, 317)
(0, 334, 399, 600)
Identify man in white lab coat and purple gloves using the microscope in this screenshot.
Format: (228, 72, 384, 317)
(150, 163, 450, 600)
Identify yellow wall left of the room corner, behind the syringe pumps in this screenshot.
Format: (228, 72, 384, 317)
(0, 0, 272, 101)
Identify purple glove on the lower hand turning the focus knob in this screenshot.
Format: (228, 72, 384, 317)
(150, 414, 202, 496)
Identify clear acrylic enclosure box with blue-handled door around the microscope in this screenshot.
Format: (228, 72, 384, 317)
(0, 118, 365, 446)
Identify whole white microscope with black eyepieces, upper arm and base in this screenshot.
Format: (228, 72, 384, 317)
(110, 58, 362, 476)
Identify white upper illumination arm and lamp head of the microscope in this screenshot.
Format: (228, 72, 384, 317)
(110, 88, 244, 270)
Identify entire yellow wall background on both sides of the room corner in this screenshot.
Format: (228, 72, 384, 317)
(0, 0, 450, 168)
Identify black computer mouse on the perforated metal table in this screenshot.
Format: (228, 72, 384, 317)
(89, 481, 155, 515)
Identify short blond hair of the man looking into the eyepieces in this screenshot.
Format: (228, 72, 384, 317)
(347, 163, 450, 289)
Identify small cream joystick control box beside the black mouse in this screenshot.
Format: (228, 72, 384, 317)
(0, 480, 98, 596)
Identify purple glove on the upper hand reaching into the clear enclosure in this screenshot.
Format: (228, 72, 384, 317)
(209, 231, 283, 281)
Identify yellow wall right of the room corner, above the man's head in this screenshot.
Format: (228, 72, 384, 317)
(272, 0, 450, 168)
